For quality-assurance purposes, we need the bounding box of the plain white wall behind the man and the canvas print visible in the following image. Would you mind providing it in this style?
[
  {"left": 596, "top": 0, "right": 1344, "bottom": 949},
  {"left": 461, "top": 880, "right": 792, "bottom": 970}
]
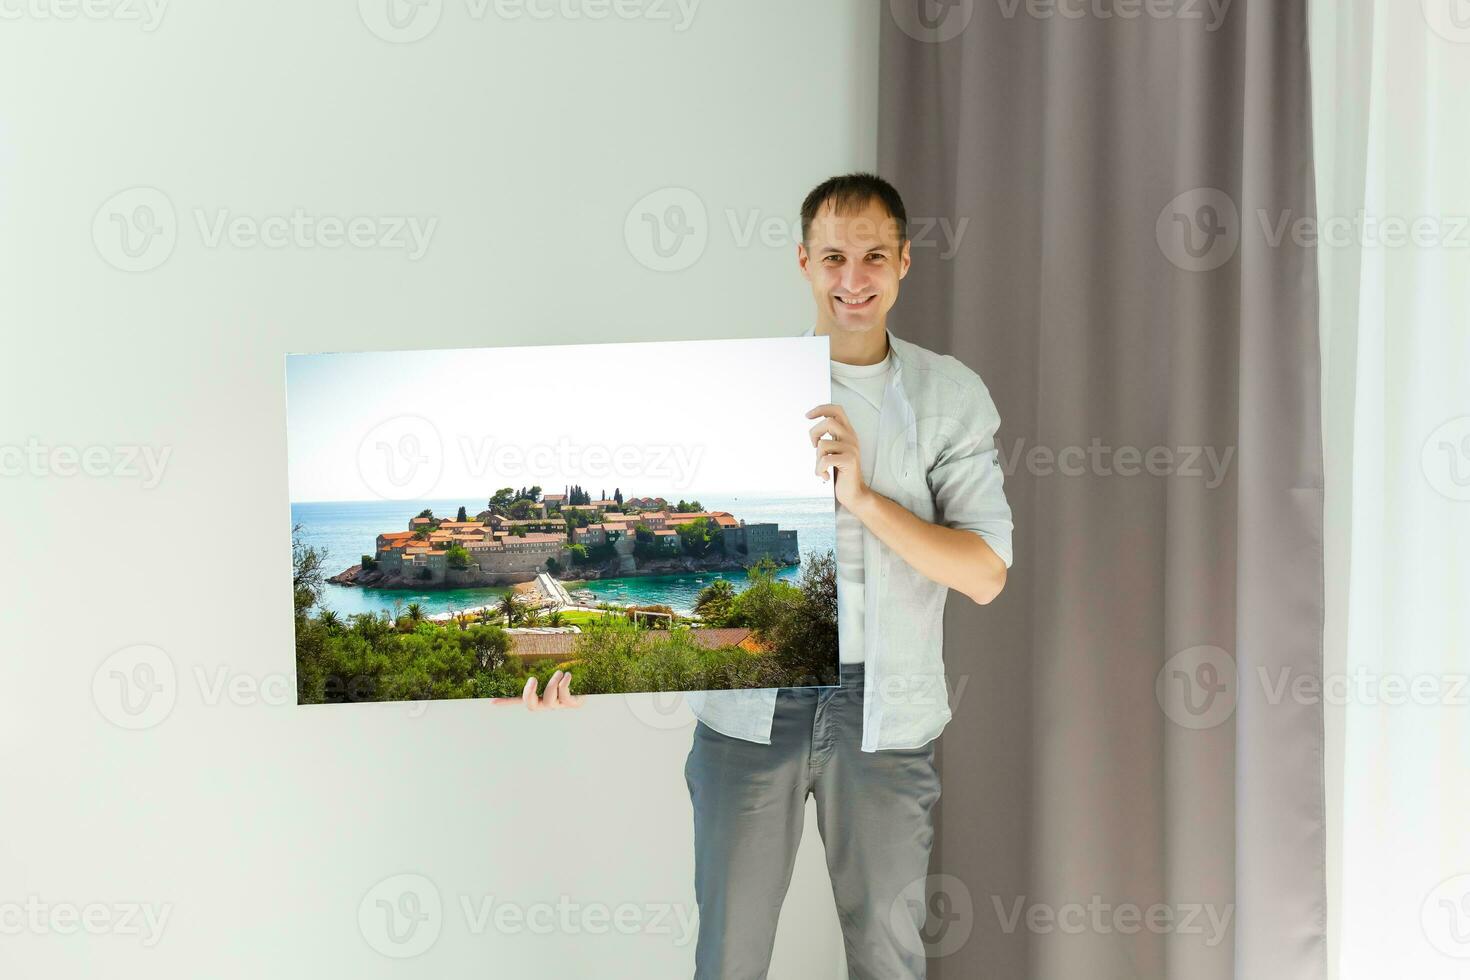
[{"left": 0, "top": 0, "right": 878, "bottom": 979}]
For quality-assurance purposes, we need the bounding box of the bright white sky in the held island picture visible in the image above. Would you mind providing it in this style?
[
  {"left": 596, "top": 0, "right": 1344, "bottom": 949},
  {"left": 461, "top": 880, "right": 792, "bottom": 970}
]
[{"left": 287, "top": 336, "right": 832, "bottom": 501}]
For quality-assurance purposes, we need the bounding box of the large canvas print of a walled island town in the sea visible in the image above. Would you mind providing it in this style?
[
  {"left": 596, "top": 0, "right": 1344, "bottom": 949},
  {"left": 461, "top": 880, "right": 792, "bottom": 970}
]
[{"left": 287, "top": 336, "right": 838, "bottom": 704}]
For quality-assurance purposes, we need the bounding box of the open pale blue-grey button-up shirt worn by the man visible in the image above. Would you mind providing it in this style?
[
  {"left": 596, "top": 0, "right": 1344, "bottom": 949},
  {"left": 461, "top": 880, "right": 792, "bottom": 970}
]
[{"left": 685, "top": 328, "right": 1013, "bottom": 752}]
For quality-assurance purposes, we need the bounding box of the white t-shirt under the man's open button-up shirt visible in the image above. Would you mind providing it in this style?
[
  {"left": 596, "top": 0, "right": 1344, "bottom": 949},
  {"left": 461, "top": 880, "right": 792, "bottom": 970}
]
[{"left": 832, "top": 351, "right": 894, "bottom": 664}]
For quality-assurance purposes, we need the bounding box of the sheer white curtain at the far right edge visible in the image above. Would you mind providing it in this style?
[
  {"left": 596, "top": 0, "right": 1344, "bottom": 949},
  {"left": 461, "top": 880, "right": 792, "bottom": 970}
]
[{"left": 1311, "top": 0, "right": 1470, "bottom": 980}]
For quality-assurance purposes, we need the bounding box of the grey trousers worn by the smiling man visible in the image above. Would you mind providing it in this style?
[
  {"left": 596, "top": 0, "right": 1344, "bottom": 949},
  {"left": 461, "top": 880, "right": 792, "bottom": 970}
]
[{"left": 684, "top": 664, "right": 939, "bottom": 980}]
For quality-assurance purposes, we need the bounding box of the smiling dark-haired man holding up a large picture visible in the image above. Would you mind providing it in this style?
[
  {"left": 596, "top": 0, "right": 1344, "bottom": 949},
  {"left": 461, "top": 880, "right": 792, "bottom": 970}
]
[{"left": 505, "top": 173, "right": 1011, "bottom": 980}]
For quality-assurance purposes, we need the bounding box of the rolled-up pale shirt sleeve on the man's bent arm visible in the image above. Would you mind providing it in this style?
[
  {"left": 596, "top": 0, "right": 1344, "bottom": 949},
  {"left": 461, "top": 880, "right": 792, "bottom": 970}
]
[{"left": 928, "top": 376, "right": 1013, "bottom": 569}]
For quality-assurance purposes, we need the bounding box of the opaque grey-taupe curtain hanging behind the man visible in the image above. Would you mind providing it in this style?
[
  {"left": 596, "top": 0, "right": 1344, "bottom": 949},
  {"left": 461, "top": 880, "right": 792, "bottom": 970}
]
[{"left": 879, "top": 0, "right": 1326, "bottom": 980}]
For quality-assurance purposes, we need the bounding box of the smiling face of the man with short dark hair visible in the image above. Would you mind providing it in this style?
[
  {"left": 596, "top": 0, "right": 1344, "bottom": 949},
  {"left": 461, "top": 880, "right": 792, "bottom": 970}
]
[{"left": 797, "top": 198, "right": 908, "bottom": 334}]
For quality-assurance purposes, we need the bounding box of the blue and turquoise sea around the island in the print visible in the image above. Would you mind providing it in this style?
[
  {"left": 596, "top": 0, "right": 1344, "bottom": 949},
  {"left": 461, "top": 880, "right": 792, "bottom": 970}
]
[{"left": 291, "top": 494, "right": 836, "bottom": 616}]
